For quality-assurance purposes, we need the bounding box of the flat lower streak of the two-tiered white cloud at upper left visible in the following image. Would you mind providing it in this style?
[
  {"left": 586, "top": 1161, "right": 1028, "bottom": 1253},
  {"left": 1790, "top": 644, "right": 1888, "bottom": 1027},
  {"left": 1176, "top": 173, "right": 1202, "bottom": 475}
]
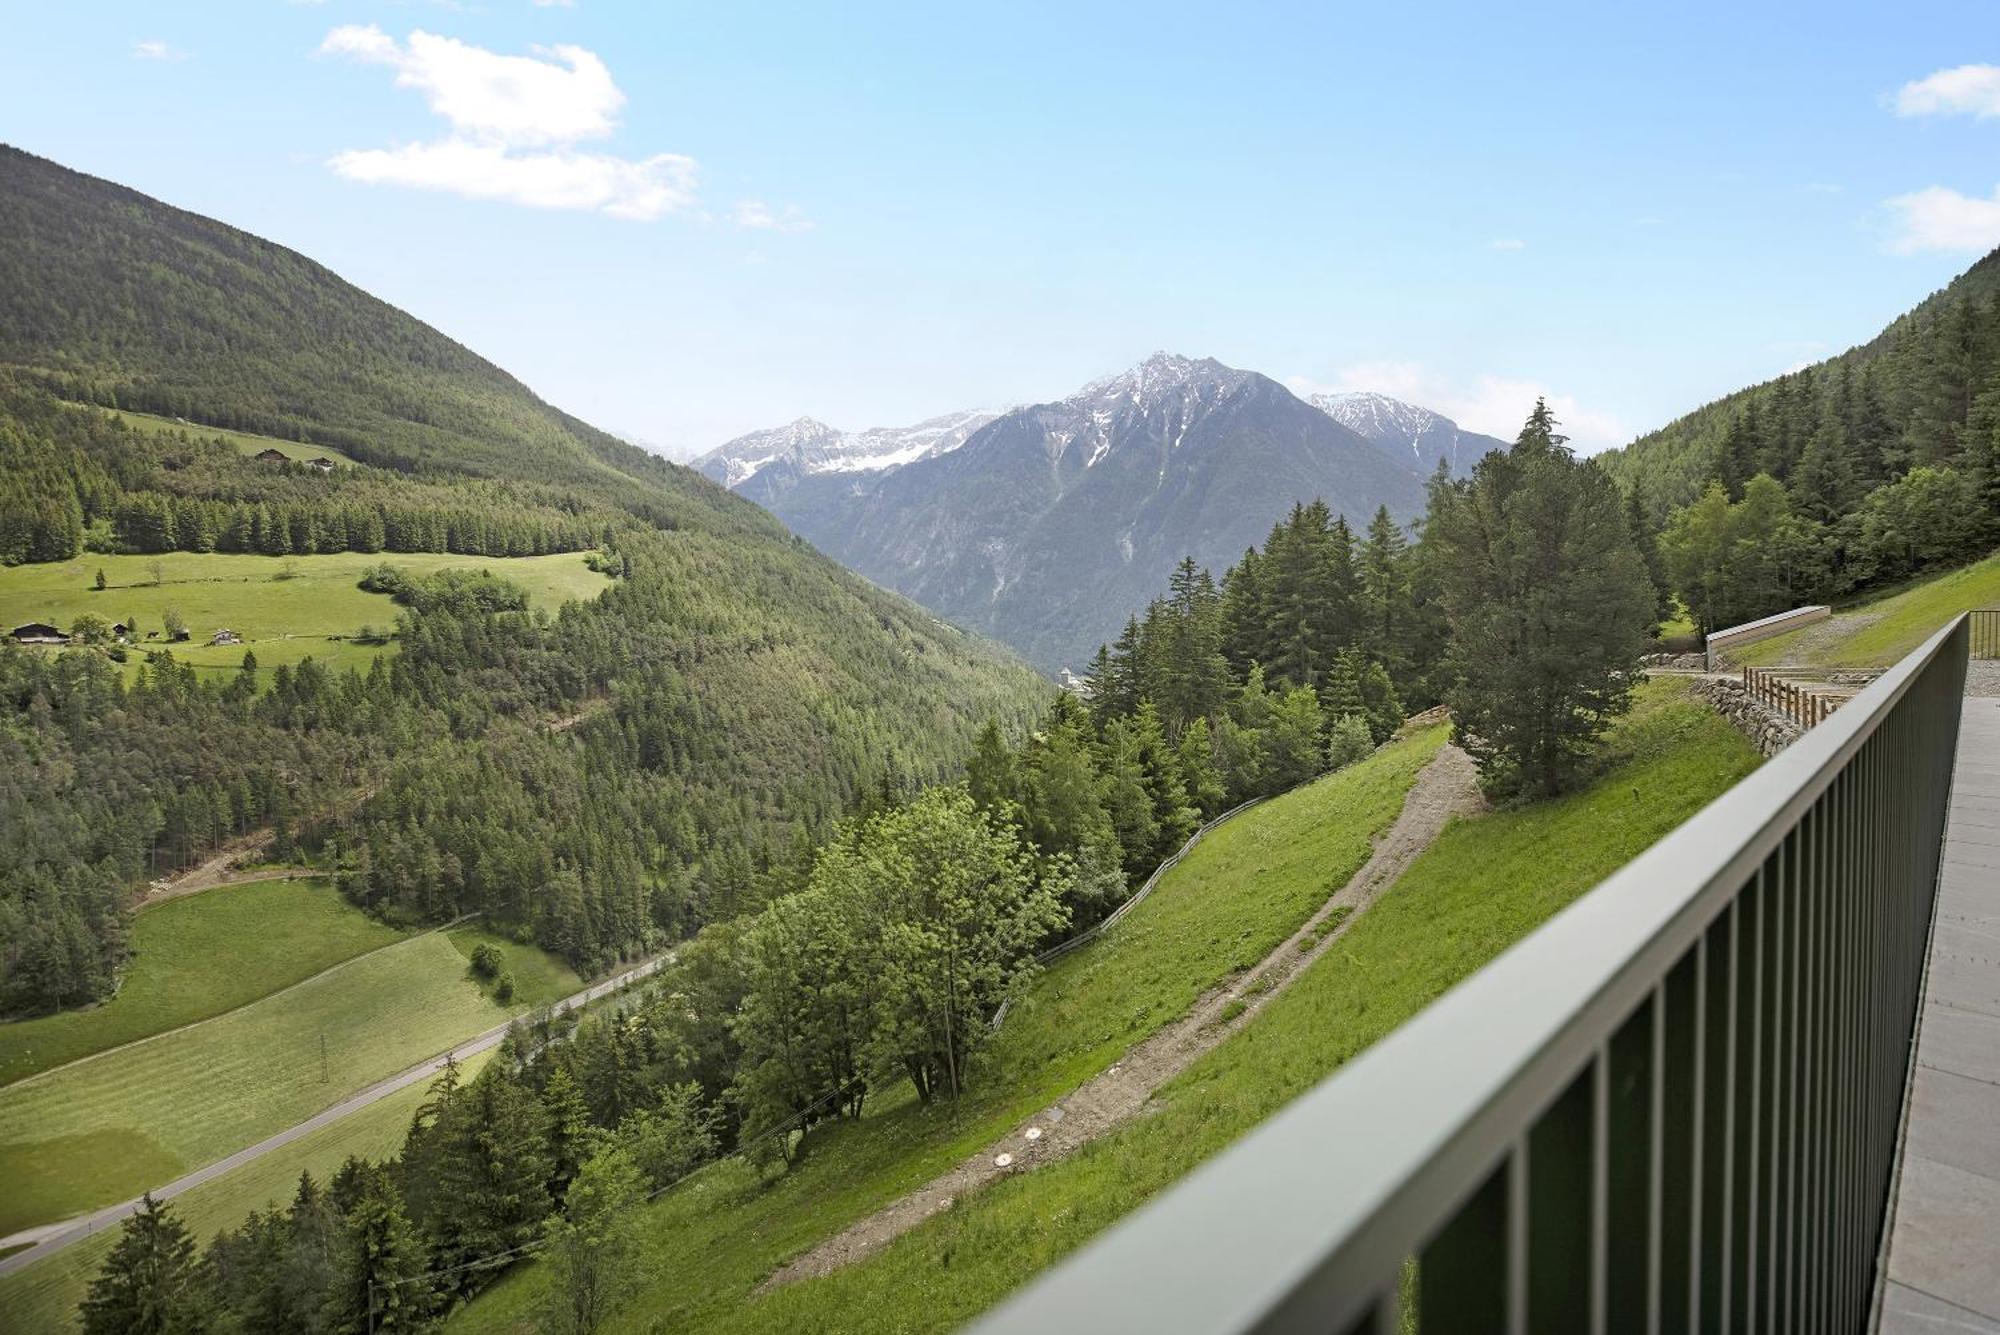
[{"left": 330, "top": 138, "right": 694, "bottom": 222}]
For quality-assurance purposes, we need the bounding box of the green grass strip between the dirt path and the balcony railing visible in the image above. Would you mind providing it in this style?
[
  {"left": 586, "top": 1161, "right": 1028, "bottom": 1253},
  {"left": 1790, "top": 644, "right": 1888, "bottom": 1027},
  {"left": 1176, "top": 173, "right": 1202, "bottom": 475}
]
[{"left": 460, "top": 681, "right": 1758, "bottom": 1335}]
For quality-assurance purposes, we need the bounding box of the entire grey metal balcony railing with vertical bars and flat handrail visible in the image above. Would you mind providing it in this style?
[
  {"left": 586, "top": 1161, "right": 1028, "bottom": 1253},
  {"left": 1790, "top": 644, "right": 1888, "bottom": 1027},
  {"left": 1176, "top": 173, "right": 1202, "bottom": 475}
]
[{"left": 982, "top": 616, "right": 1970, "bottom": 1335}]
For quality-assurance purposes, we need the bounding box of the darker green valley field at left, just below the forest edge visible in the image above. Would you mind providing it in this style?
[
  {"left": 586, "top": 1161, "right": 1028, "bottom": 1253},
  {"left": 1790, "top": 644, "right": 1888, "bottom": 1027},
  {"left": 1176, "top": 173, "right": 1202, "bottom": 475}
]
[{"left": 0, "top": 877, "right": 404, "bottom": 1085}]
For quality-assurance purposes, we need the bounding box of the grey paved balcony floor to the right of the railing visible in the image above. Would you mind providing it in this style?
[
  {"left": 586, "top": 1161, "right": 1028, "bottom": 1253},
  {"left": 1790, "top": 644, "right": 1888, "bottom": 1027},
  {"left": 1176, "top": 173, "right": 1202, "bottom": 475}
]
[{"left": 1878, "top": 695, "right": 2000, "bottom": 1335}]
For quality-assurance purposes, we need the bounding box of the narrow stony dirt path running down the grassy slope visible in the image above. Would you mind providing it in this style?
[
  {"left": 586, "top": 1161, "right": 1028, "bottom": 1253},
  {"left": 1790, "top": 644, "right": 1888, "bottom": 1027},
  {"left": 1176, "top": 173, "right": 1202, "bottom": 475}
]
[{"left": 760, "top": 745, "right": 1480, "bottom": 1291}]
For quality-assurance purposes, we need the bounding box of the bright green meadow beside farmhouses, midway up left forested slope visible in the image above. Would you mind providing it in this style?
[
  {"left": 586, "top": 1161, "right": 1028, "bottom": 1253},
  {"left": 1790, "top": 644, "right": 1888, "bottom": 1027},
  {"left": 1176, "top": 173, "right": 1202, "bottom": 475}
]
[{"left": 0, "top": 552, "right": 610, "bottom": 673}]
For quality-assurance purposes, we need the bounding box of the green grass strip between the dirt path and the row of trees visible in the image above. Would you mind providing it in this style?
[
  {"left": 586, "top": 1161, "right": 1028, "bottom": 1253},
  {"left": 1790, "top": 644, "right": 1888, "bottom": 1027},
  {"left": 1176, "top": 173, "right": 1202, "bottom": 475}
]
[{"left": 450, "top": 727, "right": 1446, "bottom": 1329}]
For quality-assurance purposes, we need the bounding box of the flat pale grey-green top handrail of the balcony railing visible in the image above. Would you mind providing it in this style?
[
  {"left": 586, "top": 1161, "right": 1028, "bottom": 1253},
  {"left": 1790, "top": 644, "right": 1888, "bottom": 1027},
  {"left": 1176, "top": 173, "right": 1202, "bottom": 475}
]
[{"left": 982, "top": 616, "right": 1966, "bottom": 1333}]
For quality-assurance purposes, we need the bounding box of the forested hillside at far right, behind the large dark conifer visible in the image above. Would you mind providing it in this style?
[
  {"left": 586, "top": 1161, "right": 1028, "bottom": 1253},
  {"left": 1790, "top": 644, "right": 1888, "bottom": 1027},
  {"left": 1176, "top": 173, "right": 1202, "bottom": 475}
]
[{"left": 1604, "top": 252, "right": 2000, "bottom": 632}]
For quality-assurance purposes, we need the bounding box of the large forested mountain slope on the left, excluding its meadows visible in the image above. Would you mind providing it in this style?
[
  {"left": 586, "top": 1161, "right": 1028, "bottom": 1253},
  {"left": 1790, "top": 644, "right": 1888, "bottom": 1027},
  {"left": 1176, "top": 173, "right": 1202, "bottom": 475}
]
[{"left": 0, "top": 148, "right": 1044, "bottom": 1011}]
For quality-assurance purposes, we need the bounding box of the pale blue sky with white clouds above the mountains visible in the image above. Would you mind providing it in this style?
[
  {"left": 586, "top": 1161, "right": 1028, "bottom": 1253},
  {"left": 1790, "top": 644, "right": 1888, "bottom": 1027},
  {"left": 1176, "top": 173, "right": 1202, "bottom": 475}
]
[{"left": 0, "top": 0, "right": 2000, "bottom": 458}]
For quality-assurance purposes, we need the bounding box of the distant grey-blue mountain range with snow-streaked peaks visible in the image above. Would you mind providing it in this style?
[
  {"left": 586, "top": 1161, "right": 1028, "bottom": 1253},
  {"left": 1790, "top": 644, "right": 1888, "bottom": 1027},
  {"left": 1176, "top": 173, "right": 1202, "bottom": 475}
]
[{"left": 696, "top": 352, "right": 1504, "bottom": 671}]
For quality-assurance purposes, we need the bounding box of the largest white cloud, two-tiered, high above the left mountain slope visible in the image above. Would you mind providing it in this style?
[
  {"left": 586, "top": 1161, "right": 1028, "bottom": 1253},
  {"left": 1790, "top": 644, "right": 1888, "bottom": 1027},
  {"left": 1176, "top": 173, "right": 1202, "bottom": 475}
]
[{"left": 320, "top": 24, "right": 696, "bottom": 220}]
